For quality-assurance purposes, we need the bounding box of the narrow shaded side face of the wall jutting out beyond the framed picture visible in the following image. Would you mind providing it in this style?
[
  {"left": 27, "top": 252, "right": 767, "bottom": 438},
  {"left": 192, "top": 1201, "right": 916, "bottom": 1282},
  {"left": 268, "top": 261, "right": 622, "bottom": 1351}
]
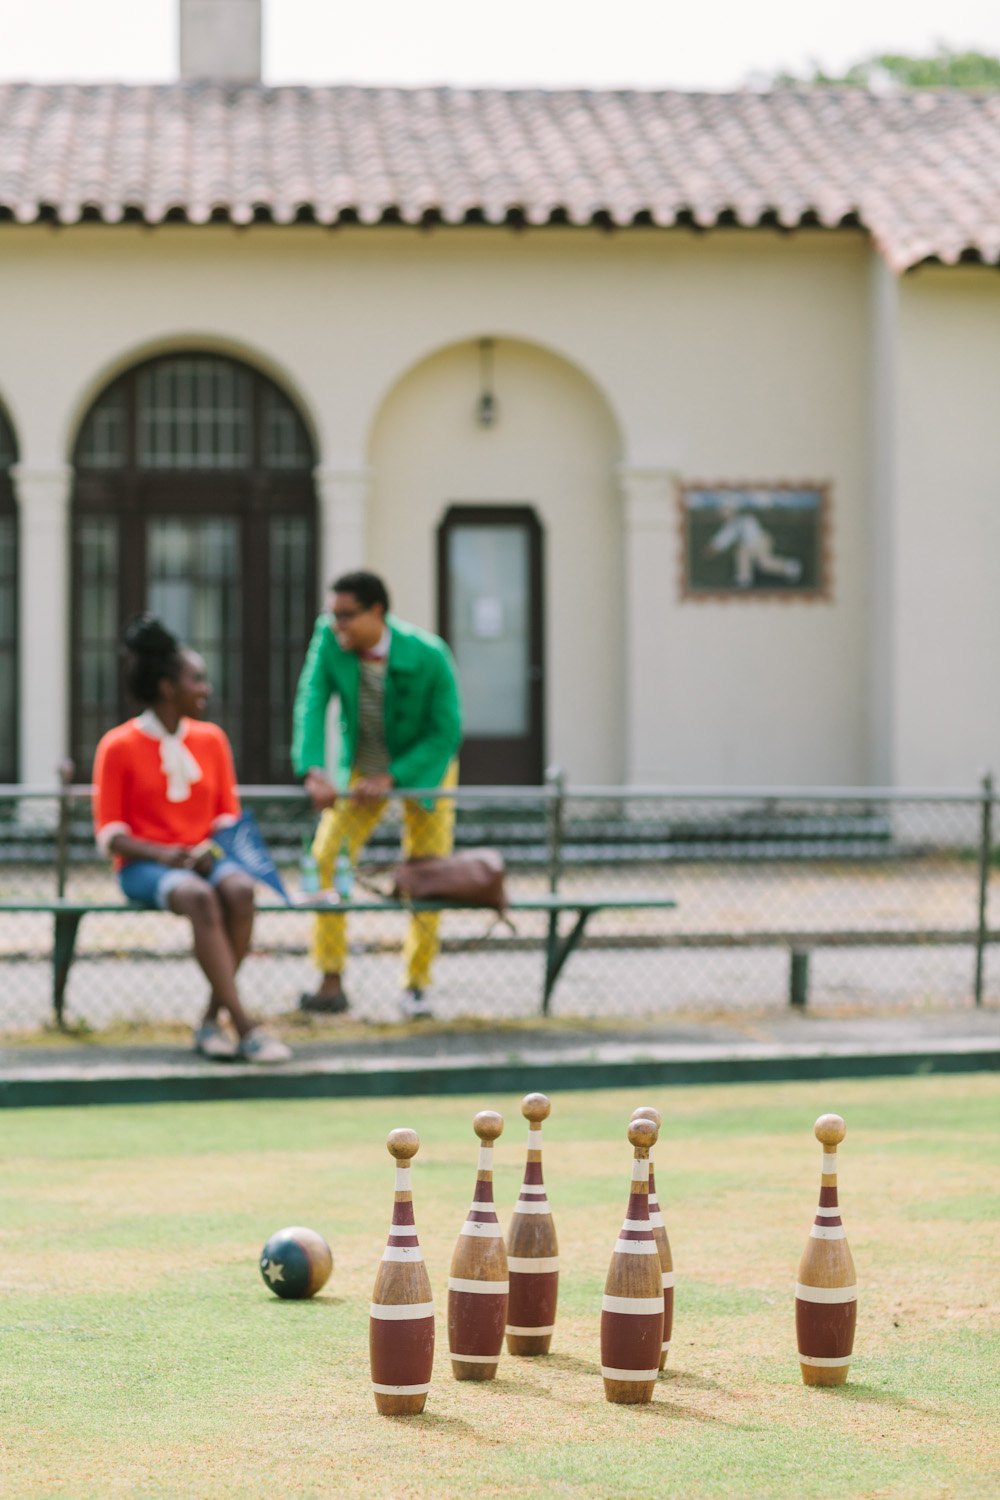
[{"left": 868, "top": 252, "right": 900, "bottom": 786}]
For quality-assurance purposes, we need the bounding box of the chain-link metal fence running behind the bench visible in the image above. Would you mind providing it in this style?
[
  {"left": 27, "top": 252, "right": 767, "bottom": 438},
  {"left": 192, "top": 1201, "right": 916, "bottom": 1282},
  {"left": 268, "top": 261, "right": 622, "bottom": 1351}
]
[{"left": 0, "top": 776, "right": 1000, "bottom": 1031}]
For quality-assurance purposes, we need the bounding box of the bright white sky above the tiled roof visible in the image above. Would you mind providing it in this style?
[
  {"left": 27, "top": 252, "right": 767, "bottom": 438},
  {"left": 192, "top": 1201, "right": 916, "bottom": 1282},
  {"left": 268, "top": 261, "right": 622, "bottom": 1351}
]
[{"left": 0, "top": 0, "right": 1000, "bottom": 89}]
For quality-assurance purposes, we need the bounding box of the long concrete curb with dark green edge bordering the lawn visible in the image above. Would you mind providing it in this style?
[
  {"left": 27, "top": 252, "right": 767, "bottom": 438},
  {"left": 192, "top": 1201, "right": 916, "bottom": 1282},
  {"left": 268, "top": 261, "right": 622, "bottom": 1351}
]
[{"left": 0, "top": 1038, "right": 1000, "bottom": 1109}]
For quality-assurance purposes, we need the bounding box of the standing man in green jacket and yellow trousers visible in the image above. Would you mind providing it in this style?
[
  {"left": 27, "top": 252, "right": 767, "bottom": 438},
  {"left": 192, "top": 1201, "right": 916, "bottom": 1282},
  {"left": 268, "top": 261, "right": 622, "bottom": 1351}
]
[{"left": 292, "top": 572, "right": 462, "bottom": 1019}]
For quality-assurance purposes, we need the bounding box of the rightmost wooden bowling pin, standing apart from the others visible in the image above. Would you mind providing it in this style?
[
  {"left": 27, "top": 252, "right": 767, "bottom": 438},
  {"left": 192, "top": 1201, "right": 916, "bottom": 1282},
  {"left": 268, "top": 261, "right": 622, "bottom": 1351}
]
[{"left": 795, "top": 1115, "right": 858, "bottom": 1386}]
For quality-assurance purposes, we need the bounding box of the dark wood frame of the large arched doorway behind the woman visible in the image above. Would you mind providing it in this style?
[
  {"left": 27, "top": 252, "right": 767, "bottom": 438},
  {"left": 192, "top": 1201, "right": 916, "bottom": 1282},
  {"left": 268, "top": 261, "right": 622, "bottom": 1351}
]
[{"left": 70, "top": 348, "right": 319, "bottom": 783}]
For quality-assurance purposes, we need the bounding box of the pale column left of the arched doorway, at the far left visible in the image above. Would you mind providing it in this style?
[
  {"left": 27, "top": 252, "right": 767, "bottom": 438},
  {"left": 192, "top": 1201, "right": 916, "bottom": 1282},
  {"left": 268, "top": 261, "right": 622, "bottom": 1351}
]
[{"left": 12, "top": 464, "right": 73, "bottom": 785}]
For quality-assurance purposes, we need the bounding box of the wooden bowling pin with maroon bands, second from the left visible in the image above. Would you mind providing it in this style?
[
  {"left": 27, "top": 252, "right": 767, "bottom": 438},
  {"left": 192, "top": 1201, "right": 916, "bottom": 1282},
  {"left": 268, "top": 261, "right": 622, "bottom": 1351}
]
[{"left": 448, "top": 1110, "right": 508, "bottom": 1380}]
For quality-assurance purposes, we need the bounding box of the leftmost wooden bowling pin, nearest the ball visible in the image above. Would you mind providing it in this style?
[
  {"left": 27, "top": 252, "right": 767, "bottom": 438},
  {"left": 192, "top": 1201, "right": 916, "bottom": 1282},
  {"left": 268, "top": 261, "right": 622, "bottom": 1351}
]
[{"left": 369, "top": 1130, "right": 433, "bottom": 1416}]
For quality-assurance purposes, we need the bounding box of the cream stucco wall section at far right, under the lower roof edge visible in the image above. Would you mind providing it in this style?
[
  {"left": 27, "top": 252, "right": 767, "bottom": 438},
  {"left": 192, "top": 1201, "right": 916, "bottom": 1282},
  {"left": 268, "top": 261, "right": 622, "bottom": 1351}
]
[{"left": 894, "top": 266, "right": 1000, "bottom": 786}]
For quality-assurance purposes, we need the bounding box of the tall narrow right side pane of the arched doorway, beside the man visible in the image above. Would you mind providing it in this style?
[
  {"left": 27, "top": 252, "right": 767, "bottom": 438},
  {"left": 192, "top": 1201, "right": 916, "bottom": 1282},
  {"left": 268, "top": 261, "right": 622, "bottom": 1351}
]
[{"left": 270, "top": 516, "right": 313, "bottom": 777}]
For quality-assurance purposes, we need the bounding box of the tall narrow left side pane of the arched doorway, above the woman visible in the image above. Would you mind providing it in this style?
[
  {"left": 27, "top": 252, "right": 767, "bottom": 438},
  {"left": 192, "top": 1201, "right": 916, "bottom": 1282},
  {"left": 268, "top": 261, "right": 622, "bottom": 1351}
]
[{"left": 75, "top": 518, "right": 118, "bottom": 765}]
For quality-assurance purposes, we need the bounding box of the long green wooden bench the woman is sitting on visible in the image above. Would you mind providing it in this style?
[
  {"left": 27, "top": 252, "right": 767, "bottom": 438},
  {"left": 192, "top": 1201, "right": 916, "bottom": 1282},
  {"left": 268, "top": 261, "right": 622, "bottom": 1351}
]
[{"left": 0, "top": 894, "right": 676, "bottom": 1026}]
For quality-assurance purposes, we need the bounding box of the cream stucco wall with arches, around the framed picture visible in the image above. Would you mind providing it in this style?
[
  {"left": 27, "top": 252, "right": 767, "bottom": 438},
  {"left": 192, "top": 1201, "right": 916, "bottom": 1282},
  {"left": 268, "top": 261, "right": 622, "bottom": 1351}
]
[{"left": 0, "top": 225, "right": 870, "bottom": 785}]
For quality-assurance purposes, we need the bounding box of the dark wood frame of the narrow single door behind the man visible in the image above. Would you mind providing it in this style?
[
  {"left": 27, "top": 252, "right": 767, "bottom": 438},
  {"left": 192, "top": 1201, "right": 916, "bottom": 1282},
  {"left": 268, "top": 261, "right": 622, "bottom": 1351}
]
[{"left": 438, "top": 503, "right": 546, "bottom": 785}]
